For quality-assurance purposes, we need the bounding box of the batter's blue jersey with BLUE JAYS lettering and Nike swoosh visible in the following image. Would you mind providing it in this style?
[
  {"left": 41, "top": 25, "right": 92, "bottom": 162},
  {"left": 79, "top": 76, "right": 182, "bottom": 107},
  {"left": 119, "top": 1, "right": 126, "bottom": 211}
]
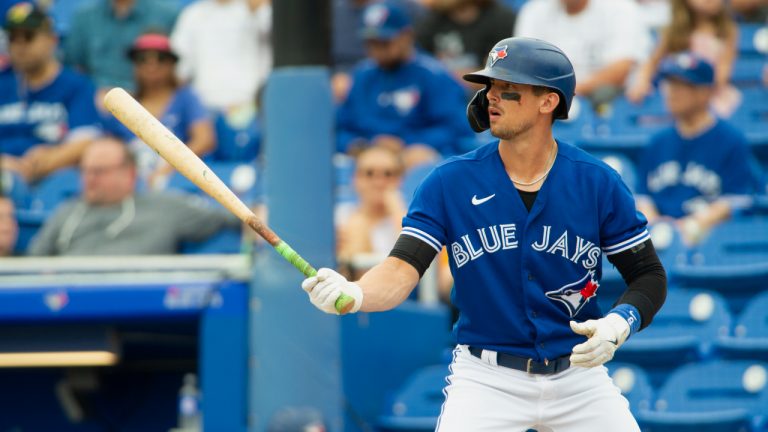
[{"left": 402, "top": 141, "right": 649, "bottom": 361}]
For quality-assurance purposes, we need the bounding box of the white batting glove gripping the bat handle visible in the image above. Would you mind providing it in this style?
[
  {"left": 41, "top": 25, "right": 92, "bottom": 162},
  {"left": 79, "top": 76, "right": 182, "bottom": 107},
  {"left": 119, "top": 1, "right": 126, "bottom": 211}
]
[{"left": 301, "top": 268, "right": 363, "bottom": 315}]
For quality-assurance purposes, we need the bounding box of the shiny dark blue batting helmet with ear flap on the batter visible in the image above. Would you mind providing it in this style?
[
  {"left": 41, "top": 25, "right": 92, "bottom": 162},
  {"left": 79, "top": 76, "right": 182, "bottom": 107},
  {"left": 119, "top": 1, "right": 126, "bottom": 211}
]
[{"left": 464, "top": 37, "right": 576, "bottom": 119}]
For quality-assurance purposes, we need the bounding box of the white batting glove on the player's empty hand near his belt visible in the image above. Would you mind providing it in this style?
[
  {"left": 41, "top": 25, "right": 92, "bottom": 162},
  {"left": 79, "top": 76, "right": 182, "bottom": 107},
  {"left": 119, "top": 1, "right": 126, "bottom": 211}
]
[{"left": 571, "top": 313, "right": 629, "bottom": 367}]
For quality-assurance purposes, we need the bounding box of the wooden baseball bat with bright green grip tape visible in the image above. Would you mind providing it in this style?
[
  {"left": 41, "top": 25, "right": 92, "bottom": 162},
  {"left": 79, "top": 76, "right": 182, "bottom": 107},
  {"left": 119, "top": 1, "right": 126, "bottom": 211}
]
[{"left": 104, "top": 87, "right": 355, "bottom": 314}]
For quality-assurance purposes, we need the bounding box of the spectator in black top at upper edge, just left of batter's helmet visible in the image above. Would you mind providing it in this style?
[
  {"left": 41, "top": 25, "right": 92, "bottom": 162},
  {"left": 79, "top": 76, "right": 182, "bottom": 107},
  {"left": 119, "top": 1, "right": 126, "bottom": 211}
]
[{"left": 416, "top": 0, "right": 515, "bottom": 82}]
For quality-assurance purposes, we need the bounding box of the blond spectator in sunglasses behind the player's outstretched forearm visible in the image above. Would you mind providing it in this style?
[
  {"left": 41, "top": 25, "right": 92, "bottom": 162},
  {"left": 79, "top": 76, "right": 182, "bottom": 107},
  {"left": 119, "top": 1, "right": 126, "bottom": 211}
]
[{"left": 337, "top": 147, "right": 406, "bottom": 277}]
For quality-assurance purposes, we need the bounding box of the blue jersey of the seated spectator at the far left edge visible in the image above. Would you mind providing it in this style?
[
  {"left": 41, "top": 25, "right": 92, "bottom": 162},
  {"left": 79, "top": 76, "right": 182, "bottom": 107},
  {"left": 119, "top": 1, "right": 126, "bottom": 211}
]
[{"left": 0, "top": 67, "right": 100, "bottom": 156}]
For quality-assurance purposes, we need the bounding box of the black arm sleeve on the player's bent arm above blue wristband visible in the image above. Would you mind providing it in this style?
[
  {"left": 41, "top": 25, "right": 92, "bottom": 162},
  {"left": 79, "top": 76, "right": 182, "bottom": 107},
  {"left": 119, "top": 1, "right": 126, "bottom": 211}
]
[{"left": 608, "top": 239, "right": 667, "bottom": 330}]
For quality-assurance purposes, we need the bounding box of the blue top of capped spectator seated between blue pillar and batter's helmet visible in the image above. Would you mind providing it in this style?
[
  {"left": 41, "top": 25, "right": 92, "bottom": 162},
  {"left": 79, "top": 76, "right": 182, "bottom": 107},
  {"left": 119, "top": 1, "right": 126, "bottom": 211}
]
[{"left": 336, "top": 54, "right": 475, "bottom": 155}]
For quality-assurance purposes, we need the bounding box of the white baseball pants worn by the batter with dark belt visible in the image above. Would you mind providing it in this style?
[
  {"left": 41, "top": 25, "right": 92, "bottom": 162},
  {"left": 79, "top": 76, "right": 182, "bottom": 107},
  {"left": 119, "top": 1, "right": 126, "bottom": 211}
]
[{"left": 437, "top": 345, "right": 640, "bottom": 432}]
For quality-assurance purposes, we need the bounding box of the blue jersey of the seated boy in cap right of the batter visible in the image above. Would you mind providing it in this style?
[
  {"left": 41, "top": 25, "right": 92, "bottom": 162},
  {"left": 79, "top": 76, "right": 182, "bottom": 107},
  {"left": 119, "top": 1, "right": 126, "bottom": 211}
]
[{"left": 636, "top": 120, "right": 759, "bottom": 218}]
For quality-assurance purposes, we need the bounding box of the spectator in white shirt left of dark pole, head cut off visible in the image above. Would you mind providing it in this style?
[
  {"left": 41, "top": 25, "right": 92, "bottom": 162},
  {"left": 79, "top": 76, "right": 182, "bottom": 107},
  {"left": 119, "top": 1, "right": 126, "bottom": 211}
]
[{"left": 171, "top": 0, "right": 272, "bottom": 111}]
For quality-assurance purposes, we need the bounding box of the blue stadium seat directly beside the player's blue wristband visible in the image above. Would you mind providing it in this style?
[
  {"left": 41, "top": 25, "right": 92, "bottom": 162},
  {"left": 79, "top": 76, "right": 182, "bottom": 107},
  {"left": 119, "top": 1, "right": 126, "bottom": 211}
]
[{"left": 615, "top": 288, "right": 731, "bottom": 387}]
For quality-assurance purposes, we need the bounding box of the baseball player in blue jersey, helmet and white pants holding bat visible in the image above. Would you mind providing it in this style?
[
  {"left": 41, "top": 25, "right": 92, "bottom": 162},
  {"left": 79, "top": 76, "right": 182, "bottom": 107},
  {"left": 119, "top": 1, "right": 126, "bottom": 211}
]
[{"left": 302, "top": 37, "right": 666, "bottom": 432}]
